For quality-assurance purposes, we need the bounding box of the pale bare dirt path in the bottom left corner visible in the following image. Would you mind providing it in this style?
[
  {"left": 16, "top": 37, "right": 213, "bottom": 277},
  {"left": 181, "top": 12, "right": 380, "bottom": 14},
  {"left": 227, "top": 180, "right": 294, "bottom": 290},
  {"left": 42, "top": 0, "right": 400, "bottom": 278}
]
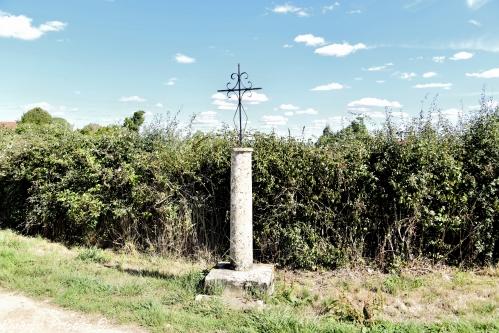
[{"left": 0, "top": 290, "right": 145, "bottom": 333}]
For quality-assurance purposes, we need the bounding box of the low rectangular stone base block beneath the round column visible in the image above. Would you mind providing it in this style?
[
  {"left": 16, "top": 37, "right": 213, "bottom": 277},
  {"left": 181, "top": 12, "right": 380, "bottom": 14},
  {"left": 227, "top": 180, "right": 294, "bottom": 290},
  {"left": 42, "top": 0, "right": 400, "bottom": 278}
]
[{"left": 204, "top": 263, "right": 274, "bottom": 295}]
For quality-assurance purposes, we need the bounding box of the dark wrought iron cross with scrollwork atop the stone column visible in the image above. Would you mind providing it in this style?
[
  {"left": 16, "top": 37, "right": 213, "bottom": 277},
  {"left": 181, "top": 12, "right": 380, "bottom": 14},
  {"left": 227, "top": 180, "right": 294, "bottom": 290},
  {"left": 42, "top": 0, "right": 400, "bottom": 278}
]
[{"left": 217, "top": 64, "right": 262, "bottom": 146}]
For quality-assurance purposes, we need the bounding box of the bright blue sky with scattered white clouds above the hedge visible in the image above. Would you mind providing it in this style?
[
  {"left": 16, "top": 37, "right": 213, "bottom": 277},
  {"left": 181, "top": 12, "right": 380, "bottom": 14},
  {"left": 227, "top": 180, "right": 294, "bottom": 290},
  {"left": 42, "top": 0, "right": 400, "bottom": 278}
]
[{"left": 0, "top": 0, "right": 499, "bottom": 135}]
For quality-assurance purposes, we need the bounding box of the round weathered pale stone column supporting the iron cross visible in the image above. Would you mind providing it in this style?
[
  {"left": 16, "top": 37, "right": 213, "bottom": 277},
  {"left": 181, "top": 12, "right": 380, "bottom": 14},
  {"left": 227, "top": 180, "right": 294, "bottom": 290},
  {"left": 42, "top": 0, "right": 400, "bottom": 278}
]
[{"left": 230, "top": 148, "right": 253, "bottom": 271}]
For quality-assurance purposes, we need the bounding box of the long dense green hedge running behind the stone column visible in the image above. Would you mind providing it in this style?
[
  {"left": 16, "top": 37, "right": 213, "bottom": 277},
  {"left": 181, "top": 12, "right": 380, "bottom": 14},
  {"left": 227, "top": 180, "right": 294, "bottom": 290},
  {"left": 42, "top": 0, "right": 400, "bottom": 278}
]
[{"left": 0, "top": 105, "right": 499, "bottom": 268}]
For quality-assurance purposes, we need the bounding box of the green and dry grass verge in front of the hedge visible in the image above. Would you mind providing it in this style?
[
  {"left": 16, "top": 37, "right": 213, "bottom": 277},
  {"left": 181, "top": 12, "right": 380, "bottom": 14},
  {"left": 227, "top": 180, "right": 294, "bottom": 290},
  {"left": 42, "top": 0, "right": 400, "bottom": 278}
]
[{"left": 0, "top": 231, "right": 499, "bottom": 332}]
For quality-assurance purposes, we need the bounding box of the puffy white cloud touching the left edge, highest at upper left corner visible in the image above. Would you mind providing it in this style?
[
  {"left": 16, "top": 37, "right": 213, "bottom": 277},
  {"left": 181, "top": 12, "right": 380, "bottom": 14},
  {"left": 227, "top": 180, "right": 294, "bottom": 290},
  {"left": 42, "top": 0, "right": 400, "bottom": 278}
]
[{"left": 0, "top": 11, "right": 67, "bottom": 40}]
